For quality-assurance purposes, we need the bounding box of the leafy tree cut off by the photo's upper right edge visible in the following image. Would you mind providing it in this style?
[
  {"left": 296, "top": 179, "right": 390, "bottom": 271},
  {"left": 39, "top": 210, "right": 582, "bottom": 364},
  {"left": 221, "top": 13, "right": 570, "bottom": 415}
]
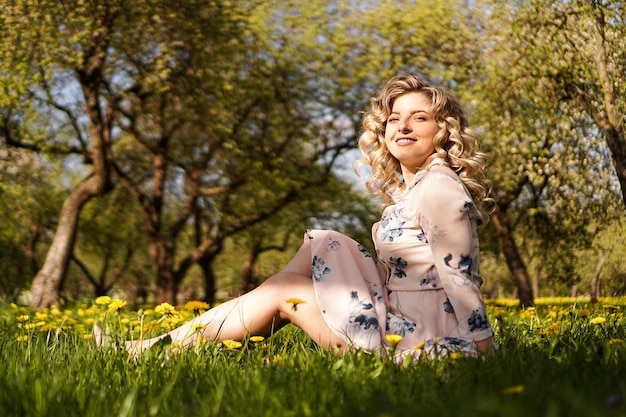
[{"left": 525, "top": 0, "right": 626, "bottom": 205}]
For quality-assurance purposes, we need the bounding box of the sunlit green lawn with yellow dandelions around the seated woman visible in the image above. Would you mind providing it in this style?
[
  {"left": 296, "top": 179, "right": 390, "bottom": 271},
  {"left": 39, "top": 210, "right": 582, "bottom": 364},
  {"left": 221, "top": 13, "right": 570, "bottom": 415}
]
[{"left": 0, "top": 303, "right": 626, "bottom": 417}]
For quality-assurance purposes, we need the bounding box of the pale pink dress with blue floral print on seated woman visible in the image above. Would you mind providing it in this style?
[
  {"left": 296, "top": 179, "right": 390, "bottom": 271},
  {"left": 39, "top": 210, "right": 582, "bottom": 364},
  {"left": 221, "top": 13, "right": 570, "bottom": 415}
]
[{"left": 305, "top": 160, "right": 493, "bottom": 360}]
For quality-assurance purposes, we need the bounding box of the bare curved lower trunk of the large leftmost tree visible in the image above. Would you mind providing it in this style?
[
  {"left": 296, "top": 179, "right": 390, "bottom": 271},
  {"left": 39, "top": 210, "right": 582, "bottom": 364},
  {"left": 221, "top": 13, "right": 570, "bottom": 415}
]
[{"left": 30, "top": 175, "right": 105, "bottom": 308}]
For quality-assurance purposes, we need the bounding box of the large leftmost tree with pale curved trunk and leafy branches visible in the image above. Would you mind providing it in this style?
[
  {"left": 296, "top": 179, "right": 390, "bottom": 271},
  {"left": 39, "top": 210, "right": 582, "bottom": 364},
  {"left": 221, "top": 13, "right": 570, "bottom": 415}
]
[{"left": 0, "top": 1, "right": 135, "bottom": 307}]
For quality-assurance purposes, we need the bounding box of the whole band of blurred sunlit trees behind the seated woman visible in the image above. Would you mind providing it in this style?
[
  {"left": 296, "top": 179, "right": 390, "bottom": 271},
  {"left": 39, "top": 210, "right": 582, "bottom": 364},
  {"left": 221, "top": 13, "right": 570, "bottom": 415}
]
[{"left": 0, "top": 0, "right": 626, "bottom": 307}]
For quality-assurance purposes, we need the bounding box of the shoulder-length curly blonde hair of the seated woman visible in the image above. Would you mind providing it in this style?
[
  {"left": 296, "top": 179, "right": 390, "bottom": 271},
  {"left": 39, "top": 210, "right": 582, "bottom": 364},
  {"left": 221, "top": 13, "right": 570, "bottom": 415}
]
[{"left": 355, "top": 74, "right": 493, "bottom": 219}]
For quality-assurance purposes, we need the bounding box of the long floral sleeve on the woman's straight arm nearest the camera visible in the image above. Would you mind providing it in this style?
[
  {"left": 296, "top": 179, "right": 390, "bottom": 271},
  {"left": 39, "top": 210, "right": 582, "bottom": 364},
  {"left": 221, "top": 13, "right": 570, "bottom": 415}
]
[{"left": 419, "top": 175, "right": 493, "bottom": 341}]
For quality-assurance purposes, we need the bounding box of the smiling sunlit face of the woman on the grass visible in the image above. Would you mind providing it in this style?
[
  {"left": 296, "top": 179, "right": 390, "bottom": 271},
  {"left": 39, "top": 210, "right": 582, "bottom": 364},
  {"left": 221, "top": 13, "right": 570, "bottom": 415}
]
[{"left": 385, "top": 93, "right": 439, "bottom": 176}]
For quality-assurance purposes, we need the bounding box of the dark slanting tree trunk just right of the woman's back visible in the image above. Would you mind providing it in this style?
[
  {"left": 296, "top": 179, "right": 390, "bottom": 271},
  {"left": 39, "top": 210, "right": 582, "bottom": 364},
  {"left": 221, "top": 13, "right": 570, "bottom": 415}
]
[{"left": 493, "top": 209, "right": 534, "bottom": 307}]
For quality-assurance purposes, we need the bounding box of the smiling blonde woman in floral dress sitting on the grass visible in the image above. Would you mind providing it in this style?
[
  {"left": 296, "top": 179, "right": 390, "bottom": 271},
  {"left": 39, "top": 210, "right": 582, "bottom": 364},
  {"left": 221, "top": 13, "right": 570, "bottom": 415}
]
[{"left": 95, "top": 75, "right": 493, "bottom": 360}]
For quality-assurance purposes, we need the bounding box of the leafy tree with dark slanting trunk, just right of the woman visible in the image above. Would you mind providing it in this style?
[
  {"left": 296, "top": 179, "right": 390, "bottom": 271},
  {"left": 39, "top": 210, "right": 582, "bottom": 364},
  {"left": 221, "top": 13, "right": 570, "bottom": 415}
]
[{"left": 473, "top": 2, "right": 611, "bottom": 305}]
